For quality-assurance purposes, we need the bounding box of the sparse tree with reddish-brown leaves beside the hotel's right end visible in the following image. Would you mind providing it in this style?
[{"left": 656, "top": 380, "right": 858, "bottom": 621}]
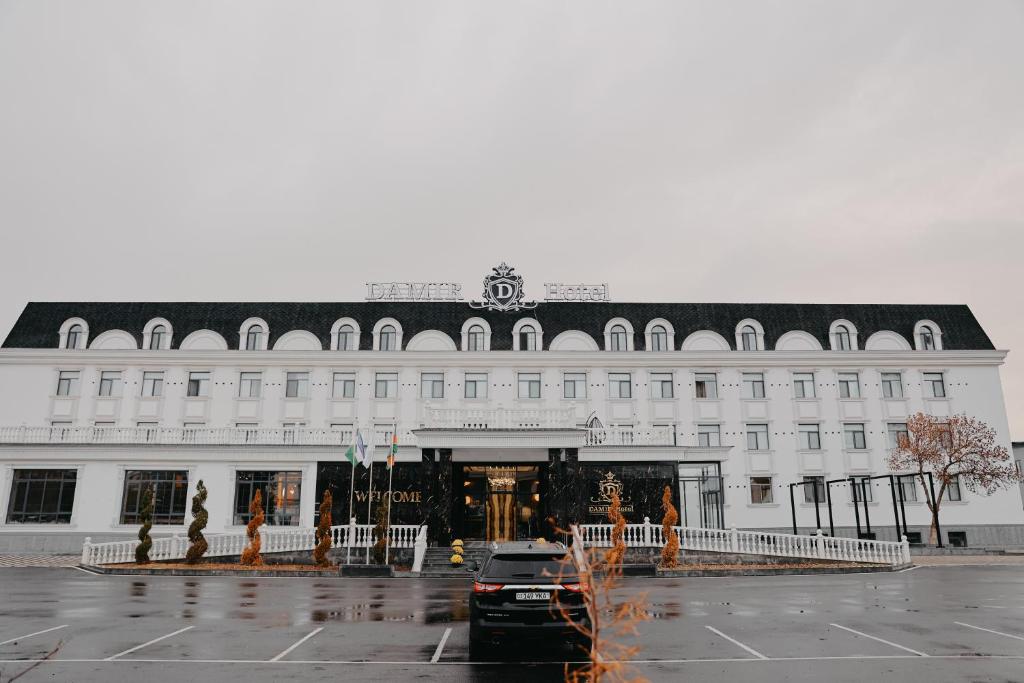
[{"left": 889, "top": 413, "right": 1021, "bottom": 545}]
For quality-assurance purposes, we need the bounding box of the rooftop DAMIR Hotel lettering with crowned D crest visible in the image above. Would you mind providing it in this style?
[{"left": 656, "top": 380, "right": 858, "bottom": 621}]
[{"left": 366, "top": 262, "right": 610, "bottom": 312}]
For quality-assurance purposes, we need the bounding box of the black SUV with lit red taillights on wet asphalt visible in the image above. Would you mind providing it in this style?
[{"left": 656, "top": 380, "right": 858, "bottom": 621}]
[{"left": 468, "top": 541, "right": 590, "bottom": 653}]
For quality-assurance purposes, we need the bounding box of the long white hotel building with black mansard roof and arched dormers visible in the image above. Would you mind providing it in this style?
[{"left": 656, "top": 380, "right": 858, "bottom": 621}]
[{"left": 0, "top": 301, "right": 1024, "bottom": 552}]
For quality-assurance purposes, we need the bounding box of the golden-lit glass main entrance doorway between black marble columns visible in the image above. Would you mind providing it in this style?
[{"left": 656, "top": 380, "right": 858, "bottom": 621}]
[{"left": 462, "top": 465, "right": 541, "bottom": 543}]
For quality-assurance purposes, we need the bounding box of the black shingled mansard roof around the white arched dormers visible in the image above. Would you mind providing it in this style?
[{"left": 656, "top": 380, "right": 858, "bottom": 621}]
[{"left": 3, "top": 301, "right": 994, "bottom": 350}]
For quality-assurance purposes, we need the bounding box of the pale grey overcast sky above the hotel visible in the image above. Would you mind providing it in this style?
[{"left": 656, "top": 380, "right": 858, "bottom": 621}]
[{"left": 0, "top": 0, "right": 1024, "bottom": 432}]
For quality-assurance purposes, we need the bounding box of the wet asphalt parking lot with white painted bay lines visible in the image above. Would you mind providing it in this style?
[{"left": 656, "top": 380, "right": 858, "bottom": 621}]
[{"left": 0, "top": 566, "right": 1024, "bottom": 683}]
